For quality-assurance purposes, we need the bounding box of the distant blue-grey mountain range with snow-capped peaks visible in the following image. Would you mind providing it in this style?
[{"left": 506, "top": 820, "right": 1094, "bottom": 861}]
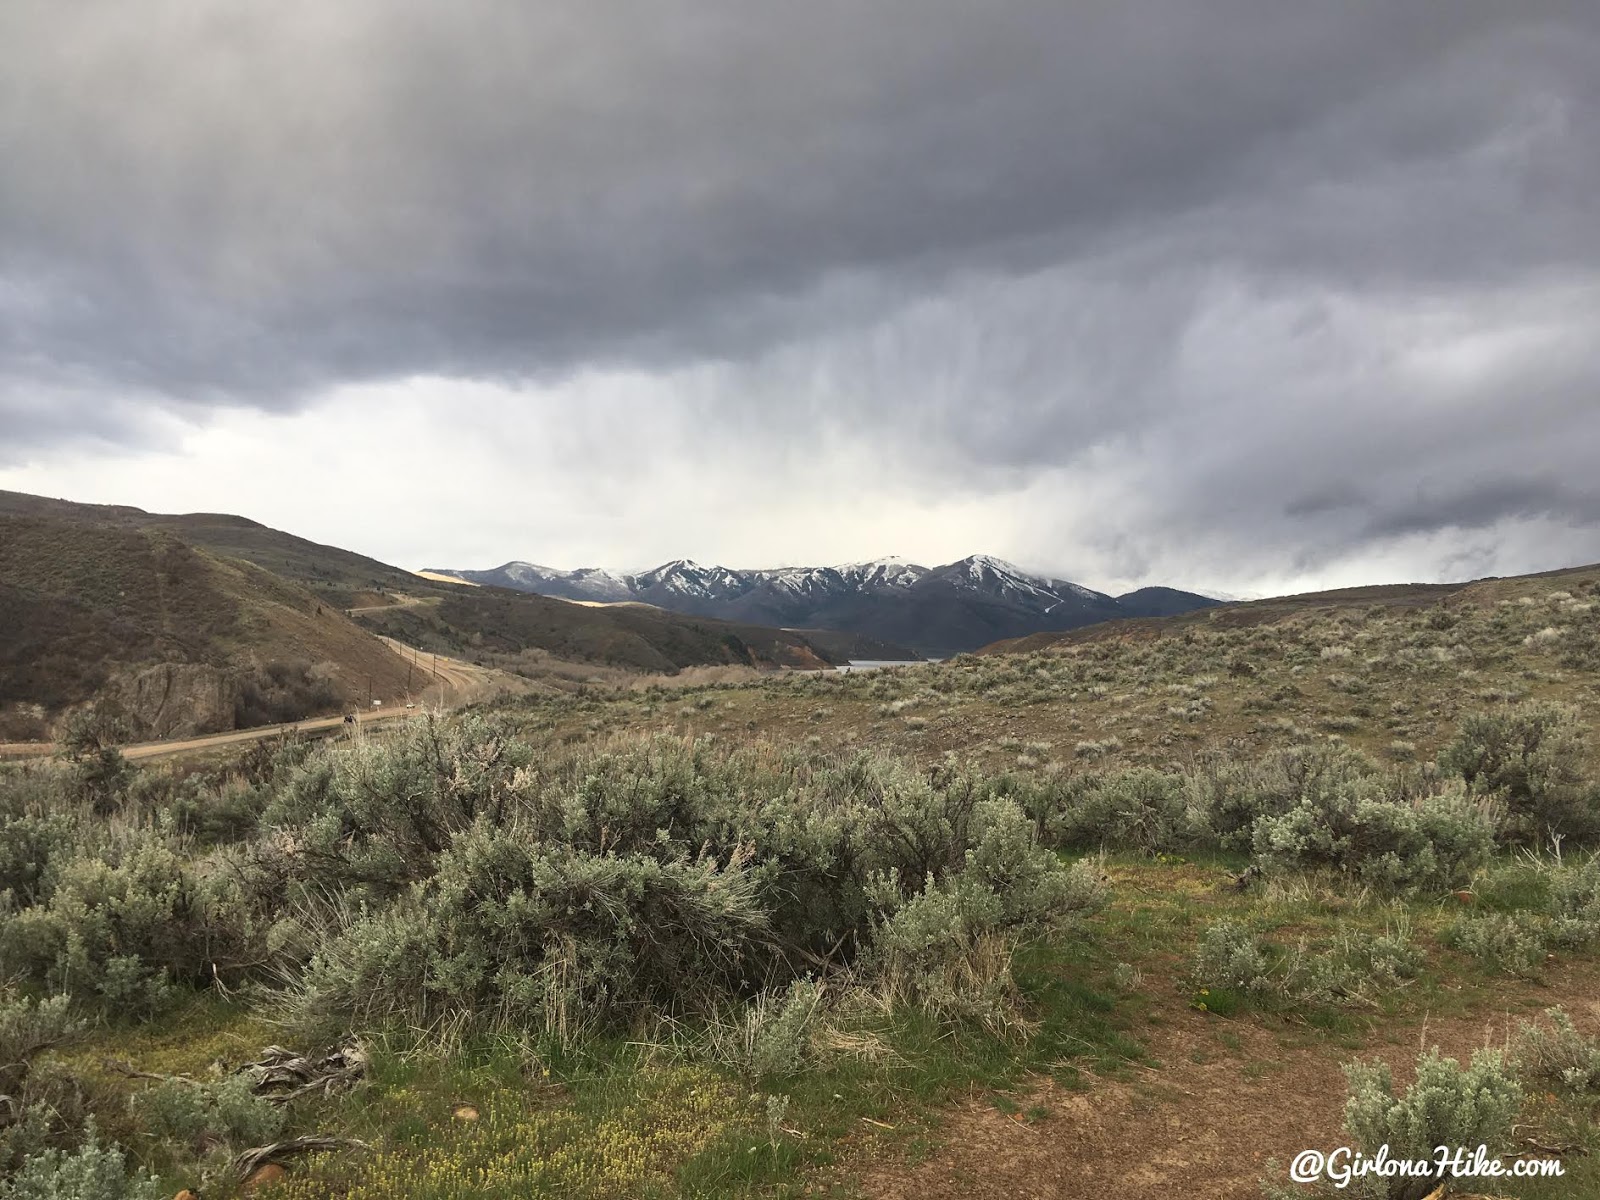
[{"left": 429, "top": 554, "right": 1219, "bottom": 654}]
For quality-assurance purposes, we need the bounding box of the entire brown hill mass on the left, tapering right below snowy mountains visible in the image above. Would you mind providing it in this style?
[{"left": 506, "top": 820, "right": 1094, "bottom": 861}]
[{"left": 0, "top": 491, "right": 910, "bottom": 741}]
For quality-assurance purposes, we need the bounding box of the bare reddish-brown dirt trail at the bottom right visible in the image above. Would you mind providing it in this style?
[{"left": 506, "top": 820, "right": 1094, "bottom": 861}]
[{"left": 835, "top": 963, "right": 1600, "bottom": 1200}]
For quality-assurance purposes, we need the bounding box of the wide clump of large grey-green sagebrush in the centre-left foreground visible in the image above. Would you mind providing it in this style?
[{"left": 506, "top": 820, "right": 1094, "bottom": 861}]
[{"left": 250, "top": 720, "right": 1098, "bottom": 1032}]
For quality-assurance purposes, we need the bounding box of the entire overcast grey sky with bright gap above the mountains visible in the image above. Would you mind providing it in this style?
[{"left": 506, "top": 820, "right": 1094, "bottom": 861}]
[{"left": 0, "top": 0, "right": 1600, "bottom": 594}]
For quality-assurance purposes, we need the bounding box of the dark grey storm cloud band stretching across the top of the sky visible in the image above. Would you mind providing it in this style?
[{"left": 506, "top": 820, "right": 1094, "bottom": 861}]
[{"left": 0, "top": 0, "right": 1594, "bottom": 403}]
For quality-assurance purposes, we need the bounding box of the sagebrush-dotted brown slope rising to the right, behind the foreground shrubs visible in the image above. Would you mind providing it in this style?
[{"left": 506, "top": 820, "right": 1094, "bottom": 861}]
[{"left": 499, "top": 566, "right": 1600, "bottom": 771}]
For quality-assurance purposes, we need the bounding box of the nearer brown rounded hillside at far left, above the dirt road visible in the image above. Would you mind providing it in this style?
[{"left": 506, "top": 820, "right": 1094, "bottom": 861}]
[{"left": 0, "top": 515, "right": 405, "bottom": 741}]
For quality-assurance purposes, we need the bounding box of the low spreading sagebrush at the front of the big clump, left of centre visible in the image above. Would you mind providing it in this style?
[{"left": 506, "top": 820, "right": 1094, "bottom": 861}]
[{"left": 304, "top": 822, "right": 774, "bottom": 1034}]
